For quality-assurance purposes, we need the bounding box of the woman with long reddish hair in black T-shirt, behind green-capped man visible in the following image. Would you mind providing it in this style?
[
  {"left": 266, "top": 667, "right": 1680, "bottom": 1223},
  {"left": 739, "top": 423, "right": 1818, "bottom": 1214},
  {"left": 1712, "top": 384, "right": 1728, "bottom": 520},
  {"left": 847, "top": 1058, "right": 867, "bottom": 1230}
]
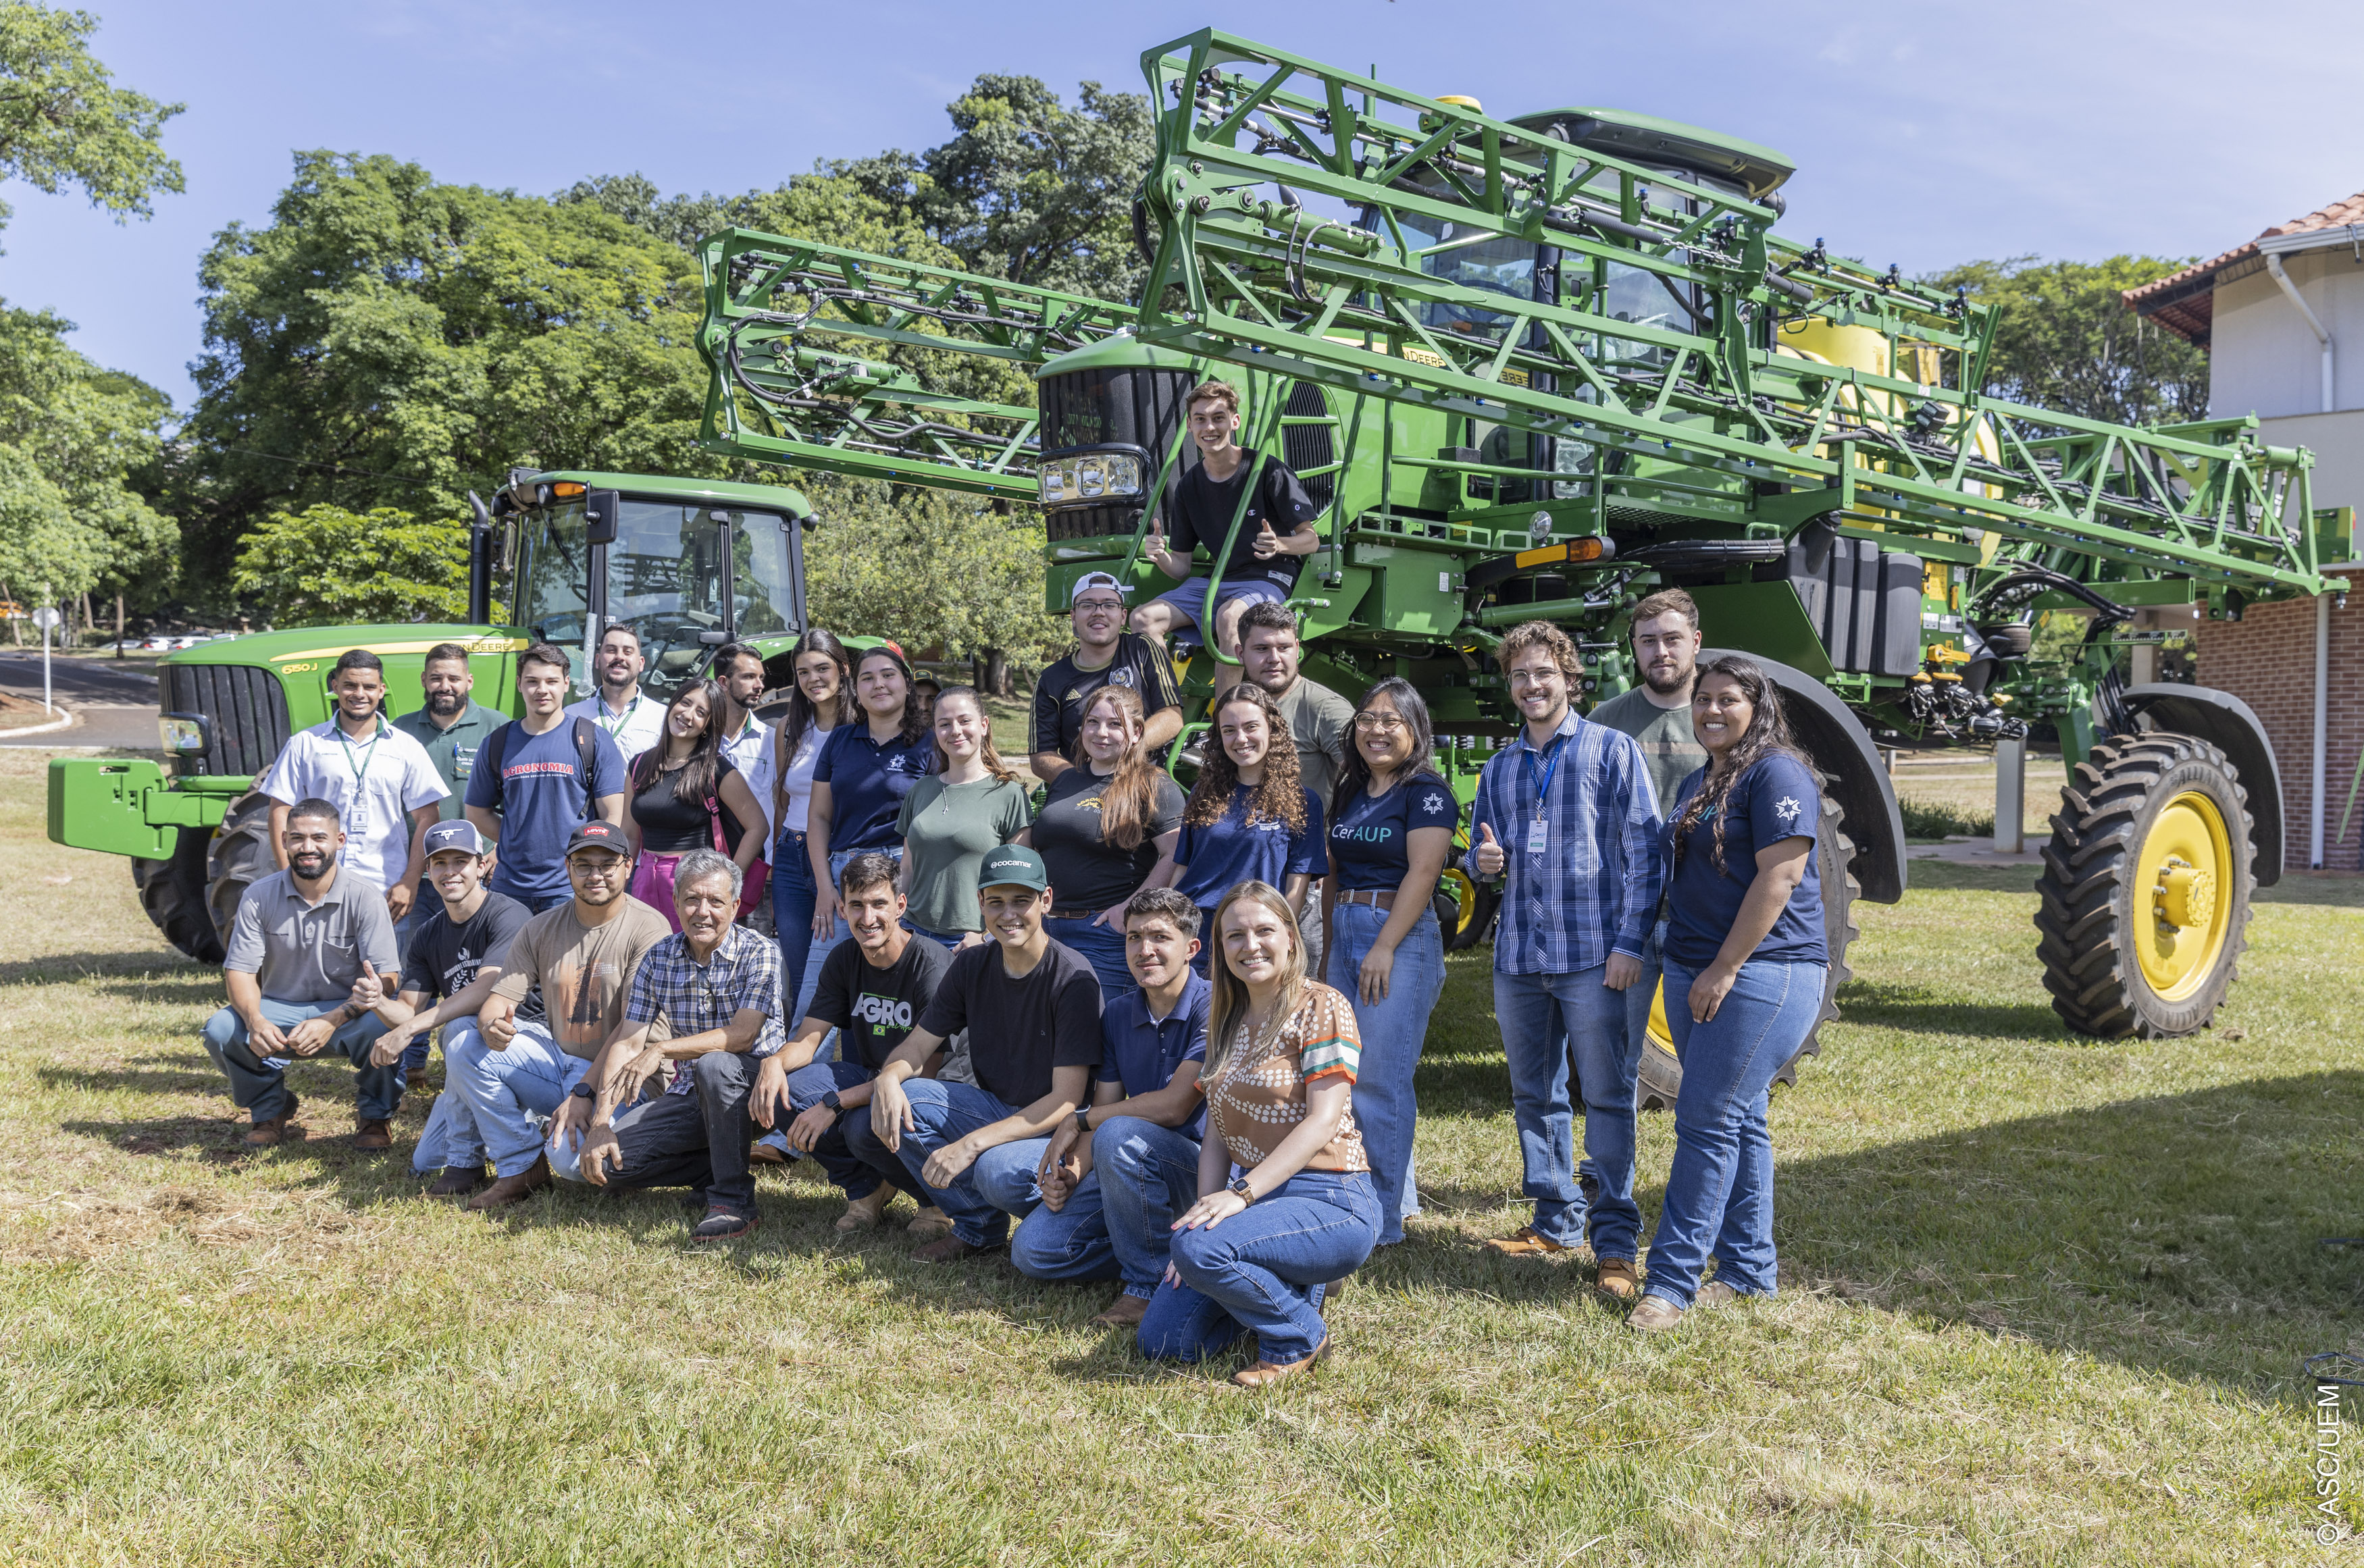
[{"left": 1019, "top": 686, "right": 1182, "bottom": 1008}]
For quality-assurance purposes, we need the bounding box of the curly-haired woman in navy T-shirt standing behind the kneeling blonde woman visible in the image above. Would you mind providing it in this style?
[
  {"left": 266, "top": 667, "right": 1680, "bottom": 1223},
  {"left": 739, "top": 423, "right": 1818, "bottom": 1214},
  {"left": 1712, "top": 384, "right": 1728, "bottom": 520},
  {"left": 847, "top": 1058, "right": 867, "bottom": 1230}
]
[{"left": 1166, "top": 681, "right": 1329, "bottom": 974}]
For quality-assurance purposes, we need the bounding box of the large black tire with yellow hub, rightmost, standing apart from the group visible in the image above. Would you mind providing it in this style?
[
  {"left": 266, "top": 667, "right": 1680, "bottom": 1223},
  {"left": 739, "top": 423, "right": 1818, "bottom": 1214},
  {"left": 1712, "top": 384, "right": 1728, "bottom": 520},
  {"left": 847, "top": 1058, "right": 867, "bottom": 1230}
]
[{"left": 2036, "top": 733, "right": 2253, "bottom": 1041}]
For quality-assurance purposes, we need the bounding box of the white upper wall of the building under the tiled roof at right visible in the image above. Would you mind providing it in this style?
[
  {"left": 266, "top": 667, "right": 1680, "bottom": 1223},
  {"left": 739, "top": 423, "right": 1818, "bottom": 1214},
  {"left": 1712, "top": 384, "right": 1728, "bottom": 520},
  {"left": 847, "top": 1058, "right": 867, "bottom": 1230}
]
[{"left": 2208, "top": 246, "right": 2364, "bottom": 421}]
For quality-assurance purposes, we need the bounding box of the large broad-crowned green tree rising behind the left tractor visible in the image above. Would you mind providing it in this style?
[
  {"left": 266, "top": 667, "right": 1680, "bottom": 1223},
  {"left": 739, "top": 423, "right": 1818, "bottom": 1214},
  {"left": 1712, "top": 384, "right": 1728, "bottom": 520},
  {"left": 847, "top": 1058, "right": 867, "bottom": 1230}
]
[{"left": 175, "top": 151, "right": 723, "bottom": 598}]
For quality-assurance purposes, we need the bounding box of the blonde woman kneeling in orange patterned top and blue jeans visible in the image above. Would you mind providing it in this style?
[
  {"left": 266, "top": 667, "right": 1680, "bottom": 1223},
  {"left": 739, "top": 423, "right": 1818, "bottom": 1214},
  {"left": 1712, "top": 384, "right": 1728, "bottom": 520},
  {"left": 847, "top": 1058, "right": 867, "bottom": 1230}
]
[{"left": 1139, "top": 882, "right": 1379, "bottom": 1388}]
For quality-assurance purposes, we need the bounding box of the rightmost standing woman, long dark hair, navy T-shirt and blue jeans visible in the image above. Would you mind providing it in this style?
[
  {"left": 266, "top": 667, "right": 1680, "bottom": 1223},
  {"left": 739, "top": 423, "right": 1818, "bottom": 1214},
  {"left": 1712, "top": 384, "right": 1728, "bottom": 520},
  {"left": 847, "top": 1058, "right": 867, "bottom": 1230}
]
[{"left": 1626, "top": 655, "right": 1830, "bottom": 1334}]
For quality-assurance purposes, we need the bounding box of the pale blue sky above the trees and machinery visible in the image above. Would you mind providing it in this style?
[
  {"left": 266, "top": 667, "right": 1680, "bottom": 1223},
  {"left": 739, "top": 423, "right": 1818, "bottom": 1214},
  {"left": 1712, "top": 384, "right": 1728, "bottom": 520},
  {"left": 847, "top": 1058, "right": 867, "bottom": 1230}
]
[{"left": 14, "top": 0, "right": 2364, "bottom": 407}]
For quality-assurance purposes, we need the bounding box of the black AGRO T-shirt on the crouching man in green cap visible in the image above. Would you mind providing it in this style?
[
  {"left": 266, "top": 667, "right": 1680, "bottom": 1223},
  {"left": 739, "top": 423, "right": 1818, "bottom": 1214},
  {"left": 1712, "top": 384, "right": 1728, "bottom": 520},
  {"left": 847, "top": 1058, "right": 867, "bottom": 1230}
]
[{"left": 920, "top": 941, "right": 1100, "bottom": 1107}]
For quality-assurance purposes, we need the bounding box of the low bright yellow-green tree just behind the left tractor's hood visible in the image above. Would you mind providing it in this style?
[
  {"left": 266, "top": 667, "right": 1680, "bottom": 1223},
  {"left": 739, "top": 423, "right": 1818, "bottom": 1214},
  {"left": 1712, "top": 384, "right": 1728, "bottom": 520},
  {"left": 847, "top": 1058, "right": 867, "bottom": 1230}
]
[{"left": 232, "top": 504, "right": 501, "bottom": 627}]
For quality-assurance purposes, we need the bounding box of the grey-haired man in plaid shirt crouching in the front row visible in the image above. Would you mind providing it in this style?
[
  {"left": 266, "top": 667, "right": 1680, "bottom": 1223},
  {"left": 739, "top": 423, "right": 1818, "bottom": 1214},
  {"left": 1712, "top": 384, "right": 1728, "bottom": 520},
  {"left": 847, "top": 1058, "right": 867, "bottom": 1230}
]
[{"left": 551, "top": 849, "right": 788, "bottom": 1242}]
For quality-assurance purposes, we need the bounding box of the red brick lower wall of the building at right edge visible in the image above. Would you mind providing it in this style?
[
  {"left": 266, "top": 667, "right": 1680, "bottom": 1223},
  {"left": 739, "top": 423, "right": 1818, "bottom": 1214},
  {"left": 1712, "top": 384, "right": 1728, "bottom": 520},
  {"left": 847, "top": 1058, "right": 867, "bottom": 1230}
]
[{"left": 2194, "top": 570, "right": 2364, "bottom": 870}]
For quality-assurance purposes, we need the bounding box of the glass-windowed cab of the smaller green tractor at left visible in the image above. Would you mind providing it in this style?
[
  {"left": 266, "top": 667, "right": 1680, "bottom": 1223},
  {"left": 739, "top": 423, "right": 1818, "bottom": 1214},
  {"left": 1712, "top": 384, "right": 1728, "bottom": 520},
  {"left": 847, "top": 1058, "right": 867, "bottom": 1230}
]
[{"left": 487, "top": 471, "right": 816, "bottom": 698}]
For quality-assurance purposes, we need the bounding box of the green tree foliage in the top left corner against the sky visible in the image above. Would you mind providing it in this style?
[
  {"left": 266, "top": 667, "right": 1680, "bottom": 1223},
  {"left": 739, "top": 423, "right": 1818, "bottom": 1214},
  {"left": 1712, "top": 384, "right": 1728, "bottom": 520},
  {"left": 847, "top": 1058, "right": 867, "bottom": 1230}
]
[{"left": 0, "top": 0, "right": 182, "bottom": 225}]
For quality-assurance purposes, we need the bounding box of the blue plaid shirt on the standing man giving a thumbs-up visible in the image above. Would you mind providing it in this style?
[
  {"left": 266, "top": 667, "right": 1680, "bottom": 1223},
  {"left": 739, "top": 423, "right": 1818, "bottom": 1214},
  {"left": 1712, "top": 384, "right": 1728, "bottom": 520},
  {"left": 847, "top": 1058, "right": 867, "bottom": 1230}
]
[{"left": 1470, "top": 710, "right": 1667, "bottom": 974}]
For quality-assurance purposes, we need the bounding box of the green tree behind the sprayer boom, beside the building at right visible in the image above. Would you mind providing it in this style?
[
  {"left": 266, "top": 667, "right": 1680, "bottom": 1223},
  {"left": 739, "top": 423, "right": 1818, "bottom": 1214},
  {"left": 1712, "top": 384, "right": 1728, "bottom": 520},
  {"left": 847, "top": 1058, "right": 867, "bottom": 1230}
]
[{"left": 1927, "top": 255, "right": 2208, "bottom": 425}]
